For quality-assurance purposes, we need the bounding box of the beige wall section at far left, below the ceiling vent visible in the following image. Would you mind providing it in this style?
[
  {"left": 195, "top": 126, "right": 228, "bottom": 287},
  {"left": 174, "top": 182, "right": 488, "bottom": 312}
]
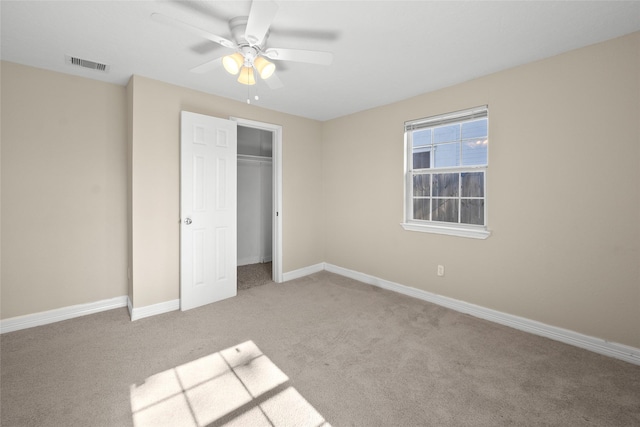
[{"left": 0, "top": 62, "right": 127, "bottom": 319}]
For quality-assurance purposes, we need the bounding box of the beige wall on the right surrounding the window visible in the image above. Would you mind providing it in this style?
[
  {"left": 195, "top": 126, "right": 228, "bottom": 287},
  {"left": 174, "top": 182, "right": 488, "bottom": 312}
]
[{"left": 323, "top": 33, "right": 640, "bottom": 347}]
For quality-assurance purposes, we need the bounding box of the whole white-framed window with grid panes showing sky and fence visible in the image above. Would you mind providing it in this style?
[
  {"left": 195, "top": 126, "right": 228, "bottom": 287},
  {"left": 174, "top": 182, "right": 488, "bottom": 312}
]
[{"left": 402, "top": 106, "right": 489, "bottom": 239}]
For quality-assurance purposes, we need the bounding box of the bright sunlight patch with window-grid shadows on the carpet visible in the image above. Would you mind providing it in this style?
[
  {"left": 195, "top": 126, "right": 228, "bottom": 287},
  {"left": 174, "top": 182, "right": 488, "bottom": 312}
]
[{"left": 130, "top": 341, "right": 330, "bottom": 427}]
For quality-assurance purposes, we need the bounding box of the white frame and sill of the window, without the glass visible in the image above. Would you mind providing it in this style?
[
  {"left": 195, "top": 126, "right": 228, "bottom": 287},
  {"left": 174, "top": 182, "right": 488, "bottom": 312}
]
[{"left": 400, "top": 105, "right": 491, "bottom": 239}]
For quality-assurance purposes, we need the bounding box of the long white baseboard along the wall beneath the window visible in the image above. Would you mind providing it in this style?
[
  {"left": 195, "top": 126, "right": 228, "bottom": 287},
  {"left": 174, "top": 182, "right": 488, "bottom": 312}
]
[{"left": 324, "top": 264, "right": 640, "bottom": 365}]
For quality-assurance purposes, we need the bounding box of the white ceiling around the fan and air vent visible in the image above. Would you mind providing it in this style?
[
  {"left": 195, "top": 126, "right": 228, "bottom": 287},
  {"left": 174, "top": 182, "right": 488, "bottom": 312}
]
[{"left": 0, "top": 0, "right": 640, "bottom": 120}]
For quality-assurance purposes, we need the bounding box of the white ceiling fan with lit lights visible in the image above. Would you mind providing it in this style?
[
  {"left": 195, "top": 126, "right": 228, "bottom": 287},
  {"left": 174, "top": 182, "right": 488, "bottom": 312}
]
[{"left": 151, "top": 0, "right": 333, "bottom": 89}]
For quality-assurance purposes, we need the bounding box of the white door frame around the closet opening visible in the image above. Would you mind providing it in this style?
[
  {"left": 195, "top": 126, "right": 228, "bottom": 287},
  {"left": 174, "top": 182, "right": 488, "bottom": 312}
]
[{"left": 229, "top": 117, "right": 283, "bottom": 283}]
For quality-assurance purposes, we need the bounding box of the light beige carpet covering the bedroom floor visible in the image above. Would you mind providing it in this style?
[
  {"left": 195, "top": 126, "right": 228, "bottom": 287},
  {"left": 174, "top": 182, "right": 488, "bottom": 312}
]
[{"left": 0, "top": 272, "right": 640, "bottom": 427}]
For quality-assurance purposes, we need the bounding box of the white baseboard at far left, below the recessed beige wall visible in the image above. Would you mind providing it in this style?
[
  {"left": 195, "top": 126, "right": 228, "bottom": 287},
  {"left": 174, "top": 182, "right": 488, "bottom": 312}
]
[{"left": 0, "top": 296, "right": 129, "bottom": 334}]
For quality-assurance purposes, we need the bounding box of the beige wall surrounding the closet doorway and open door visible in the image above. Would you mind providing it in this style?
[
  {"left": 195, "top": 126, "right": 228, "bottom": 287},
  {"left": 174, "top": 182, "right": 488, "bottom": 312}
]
[{"left": 129, "top": 76, "right": 323, "bottom": 308}]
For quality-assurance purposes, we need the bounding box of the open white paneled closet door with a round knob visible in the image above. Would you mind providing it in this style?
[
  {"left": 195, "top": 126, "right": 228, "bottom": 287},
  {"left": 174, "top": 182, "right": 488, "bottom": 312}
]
[{"left": 180, "top": 111, "right": 237, "bottom": 310}]
